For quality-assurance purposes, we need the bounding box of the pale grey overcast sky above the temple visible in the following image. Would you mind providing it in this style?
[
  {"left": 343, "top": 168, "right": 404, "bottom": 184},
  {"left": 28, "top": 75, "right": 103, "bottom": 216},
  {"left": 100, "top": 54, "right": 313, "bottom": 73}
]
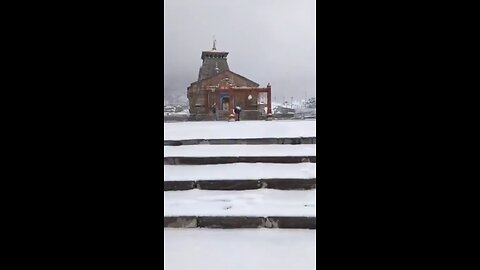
[{"left": 164, "top": 0, "right": 316, "bottom": 101}]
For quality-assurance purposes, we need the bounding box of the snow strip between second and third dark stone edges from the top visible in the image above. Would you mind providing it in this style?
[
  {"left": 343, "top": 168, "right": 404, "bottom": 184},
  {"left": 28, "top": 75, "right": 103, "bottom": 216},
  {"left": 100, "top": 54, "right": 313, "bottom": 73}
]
[{"left": 163, "top": 163, "right": 317, "bottom": 181}]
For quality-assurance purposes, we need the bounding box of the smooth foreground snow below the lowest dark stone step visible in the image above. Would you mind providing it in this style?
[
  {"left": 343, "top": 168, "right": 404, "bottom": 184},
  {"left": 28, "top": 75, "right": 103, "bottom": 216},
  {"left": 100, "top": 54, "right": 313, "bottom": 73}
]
[{"left": 164, "top": 228, "right": 316, "bottom": 270}]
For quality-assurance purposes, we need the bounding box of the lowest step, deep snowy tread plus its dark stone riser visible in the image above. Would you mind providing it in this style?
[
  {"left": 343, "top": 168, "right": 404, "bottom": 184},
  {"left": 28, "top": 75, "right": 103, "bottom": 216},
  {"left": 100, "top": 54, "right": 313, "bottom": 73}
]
[{"left": 164, "top": 189, "right": 316, "bottom": 229}]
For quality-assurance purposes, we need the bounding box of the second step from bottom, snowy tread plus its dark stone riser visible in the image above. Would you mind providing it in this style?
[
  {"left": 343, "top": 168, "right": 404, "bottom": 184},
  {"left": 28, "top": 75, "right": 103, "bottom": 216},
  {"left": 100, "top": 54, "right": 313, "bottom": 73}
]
[{"left": 163, "top": 163, "right": 316, "bottom": 191}]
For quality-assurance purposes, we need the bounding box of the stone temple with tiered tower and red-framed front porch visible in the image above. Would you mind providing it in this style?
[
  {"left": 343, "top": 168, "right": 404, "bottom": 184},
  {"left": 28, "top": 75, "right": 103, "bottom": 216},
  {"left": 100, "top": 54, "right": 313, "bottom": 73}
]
[{"left": 187, "top": 41, "right": 272, "bottom": 120}]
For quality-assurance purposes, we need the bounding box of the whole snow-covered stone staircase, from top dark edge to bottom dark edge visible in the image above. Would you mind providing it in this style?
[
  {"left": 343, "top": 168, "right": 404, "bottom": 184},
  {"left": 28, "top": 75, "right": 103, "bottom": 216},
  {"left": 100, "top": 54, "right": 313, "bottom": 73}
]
[{"left": 164, "top": 130, "right": 316, "bottom": 229}]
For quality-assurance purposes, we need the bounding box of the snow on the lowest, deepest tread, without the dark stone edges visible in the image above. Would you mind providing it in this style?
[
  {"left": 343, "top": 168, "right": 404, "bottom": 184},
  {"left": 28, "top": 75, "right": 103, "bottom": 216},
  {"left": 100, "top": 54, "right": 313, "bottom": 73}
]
[{"left": 163, "top": 189, "right": 316, "bottom": 217}]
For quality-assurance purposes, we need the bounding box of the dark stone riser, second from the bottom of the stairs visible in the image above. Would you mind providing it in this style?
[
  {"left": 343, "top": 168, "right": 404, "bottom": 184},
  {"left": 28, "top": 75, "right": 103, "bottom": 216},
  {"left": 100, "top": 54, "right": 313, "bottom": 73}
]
[{"left": 163, "top": 178, "right": 317, "bottom": 191}]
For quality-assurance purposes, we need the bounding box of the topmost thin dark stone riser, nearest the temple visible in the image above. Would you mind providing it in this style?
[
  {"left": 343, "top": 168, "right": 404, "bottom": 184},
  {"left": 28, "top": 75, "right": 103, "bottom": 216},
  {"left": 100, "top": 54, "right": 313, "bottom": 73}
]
[{"left": 163, "top": 137, "right": 317, "bottom": 146}]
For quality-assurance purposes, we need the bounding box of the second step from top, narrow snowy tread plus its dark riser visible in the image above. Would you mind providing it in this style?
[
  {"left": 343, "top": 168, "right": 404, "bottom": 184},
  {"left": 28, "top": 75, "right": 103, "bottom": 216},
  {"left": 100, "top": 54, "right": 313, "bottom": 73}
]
[{"left": 163, "top": 144, "right": 316, "bottom": 165}]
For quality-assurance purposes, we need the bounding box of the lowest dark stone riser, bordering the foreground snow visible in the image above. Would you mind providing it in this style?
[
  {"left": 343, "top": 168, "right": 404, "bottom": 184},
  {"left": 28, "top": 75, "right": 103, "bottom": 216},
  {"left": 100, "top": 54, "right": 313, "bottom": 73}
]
[{"left": 163, "top": 216, "right": 317, "bottom": 229}]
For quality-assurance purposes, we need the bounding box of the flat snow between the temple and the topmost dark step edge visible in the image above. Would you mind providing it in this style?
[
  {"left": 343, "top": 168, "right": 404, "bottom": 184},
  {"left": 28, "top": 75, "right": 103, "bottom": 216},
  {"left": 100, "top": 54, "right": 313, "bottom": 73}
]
[{"left": 163, "top": 120, "right": 316, "bottom": 140}]
